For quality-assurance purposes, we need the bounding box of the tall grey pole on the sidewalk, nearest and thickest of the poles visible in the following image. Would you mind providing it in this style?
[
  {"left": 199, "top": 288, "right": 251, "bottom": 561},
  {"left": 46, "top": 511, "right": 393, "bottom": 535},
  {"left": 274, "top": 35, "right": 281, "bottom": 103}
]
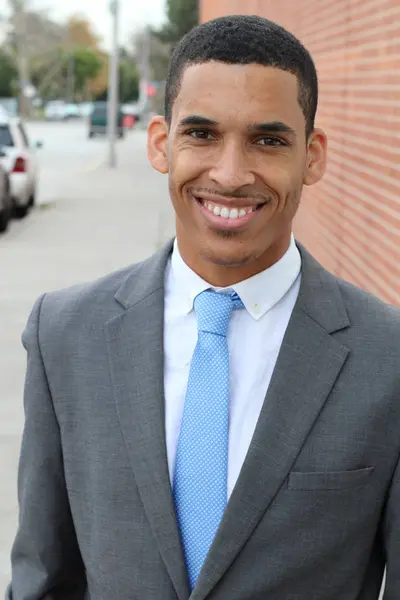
[{"left": 108, "top": 0, "right": 119, "bottom": 168}]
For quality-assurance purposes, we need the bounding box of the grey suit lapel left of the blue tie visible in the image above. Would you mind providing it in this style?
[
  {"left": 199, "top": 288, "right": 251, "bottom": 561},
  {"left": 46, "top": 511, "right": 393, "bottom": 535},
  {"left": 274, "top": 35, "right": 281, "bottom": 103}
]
[{"left": 106, "top": 245, "right": 189, "bottom": 600}]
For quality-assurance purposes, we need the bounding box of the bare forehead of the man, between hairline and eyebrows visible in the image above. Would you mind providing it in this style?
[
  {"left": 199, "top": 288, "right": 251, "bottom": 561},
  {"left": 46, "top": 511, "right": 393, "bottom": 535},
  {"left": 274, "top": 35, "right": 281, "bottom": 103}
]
[{"left": 173, "top": 62, "right": 305, "bottom": 129}]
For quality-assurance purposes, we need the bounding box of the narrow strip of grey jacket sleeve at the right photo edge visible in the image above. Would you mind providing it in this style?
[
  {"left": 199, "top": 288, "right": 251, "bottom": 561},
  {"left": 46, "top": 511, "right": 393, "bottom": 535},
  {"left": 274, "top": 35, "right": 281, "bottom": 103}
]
[{"left": 383, "top": 452, "right": 400, "bottom": 600}]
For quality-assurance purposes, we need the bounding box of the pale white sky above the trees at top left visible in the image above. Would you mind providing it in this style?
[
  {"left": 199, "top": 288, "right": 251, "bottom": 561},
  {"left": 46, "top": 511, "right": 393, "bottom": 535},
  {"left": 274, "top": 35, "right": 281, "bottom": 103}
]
[{"left": 0, "top": 0, "right": 166, "bottom": 48}]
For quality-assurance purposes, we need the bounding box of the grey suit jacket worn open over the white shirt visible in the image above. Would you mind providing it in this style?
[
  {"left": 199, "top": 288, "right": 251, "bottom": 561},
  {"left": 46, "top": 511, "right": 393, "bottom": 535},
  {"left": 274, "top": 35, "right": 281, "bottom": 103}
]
[{"left": 7, "top": 244, "right": 400, "bottom": 600}]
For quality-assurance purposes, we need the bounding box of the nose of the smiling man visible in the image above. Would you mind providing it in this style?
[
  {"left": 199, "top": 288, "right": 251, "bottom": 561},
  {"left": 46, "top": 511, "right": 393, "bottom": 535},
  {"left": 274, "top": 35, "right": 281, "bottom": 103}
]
[{"left": 210, "top": 142, "right": 255, "bottom": 190}]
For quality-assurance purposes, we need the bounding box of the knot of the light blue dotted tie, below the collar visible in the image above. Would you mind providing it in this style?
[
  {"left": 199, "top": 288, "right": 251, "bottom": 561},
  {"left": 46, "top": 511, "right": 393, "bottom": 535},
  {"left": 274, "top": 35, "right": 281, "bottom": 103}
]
[{"left": 194, "top": 290, "right": 244, "bottom": 336}]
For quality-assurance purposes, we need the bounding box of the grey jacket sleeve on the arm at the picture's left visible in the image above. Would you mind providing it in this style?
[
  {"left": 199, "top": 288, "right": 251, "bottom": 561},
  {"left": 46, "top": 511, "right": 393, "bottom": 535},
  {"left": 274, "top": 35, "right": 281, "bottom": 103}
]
[{"left": 6, "top": 296, "right": 86, "bottom": 600}]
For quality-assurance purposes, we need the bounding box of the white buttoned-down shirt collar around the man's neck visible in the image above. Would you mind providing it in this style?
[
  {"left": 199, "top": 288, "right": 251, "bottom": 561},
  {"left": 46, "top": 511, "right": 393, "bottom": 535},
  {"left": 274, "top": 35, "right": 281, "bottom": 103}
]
[{"left": 169, "top": 236, "right": 301, "bottom": 321}]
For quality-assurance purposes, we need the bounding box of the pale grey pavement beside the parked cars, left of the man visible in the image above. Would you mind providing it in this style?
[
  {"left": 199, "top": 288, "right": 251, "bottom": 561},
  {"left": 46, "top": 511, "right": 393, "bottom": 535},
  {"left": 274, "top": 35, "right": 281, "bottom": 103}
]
[{"left": 0, "top": 123, "right": 173, "bottom": 597}]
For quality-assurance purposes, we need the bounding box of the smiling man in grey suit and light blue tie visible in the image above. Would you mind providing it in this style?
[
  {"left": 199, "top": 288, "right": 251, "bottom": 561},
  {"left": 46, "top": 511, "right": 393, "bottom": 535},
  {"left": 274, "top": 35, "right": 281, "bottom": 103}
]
[{"left": 7, "top": 16, "right": 400, "bottom": 600}]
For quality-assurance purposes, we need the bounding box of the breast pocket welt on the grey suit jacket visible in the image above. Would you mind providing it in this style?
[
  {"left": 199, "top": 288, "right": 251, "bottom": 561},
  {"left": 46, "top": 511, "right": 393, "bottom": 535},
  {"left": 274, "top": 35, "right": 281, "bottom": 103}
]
[{"left": 288, "top": 467, "right": 374, "bottom": 491}]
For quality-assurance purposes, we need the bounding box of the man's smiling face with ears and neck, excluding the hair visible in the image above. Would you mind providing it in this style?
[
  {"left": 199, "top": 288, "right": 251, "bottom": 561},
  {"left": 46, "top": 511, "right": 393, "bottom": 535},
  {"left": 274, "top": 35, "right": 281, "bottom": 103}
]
[{"left": 148, "top": 62, "right": 326, "bottom": 286}]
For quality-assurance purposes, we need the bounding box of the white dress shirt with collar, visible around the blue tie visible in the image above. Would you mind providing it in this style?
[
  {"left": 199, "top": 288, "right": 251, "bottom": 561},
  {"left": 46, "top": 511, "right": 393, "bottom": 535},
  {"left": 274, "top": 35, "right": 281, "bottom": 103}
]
[{"left": 164, "top": 238, "right": 301, "bottom": 497}]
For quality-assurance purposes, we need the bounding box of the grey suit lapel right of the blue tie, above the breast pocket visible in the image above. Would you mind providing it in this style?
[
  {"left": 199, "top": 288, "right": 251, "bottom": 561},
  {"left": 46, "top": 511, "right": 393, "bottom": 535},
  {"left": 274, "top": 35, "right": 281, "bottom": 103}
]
[{"left": 191, "top": 247, "right": 349, "bottom": 600}]
